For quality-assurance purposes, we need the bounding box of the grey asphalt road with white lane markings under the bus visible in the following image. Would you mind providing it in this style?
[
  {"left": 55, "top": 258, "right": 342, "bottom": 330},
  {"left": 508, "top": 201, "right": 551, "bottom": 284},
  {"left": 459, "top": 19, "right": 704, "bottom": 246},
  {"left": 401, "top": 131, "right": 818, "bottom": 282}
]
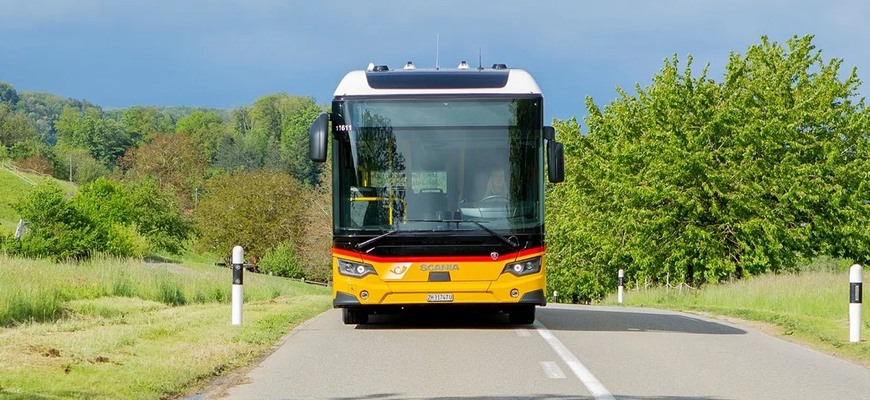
[{"left": 200, "top": 305, "right": 870, "bottom": 400}]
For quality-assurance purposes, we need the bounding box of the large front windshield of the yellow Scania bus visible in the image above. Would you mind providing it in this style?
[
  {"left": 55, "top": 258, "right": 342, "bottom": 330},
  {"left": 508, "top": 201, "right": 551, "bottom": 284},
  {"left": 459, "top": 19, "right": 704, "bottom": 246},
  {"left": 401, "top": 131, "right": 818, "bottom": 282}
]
[{"left": 332, "top": 96, "right": 543, "bottom": 234}]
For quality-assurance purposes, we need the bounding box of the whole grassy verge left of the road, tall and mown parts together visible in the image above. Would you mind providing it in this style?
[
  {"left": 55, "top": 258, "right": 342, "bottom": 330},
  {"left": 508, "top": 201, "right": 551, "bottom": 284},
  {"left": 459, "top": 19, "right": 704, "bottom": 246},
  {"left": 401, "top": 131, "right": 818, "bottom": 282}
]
[{"left": 0, "top": 256, "right": 330, "bottom": 399}]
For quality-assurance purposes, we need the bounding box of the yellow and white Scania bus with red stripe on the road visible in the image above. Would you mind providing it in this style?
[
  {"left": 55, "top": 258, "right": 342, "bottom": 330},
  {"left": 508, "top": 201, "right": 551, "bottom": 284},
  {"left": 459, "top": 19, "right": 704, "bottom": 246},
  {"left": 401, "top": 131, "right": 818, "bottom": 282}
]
[{"left": 309, "top": 62, "right": 564, "bottom": 324}]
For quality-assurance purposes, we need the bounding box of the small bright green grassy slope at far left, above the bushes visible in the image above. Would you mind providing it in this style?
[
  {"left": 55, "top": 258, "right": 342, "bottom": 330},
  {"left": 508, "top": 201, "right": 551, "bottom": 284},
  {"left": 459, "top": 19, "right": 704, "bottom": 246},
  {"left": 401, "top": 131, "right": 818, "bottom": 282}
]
[{"left": 0, "top": 163, "right": 78, "bottom": 235}]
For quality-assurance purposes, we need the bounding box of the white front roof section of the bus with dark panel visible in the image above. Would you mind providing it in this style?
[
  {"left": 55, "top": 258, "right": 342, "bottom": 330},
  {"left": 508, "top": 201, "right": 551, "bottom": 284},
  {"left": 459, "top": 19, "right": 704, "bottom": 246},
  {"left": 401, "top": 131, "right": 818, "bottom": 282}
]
[{"left": 334, "top": 65, "right": 541, "bottom": 98}]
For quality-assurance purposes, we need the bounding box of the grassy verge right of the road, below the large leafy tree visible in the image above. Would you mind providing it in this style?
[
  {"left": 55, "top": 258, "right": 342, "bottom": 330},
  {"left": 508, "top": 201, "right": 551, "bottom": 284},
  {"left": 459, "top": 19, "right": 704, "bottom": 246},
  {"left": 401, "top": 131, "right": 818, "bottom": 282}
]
[{"left": 605, "top": 268, "right": 870, "bottom": 367}]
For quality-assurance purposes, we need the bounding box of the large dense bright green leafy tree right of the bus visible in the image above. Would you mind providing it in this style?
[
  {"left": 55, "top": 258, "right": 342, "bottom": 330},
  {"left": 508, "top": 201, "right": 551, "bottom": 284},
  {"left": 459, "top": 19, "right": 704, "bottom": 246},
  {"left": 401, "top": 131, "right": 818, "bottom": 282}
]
[{"left": 547, "top": 36, "right": 870, "bottom": 299}]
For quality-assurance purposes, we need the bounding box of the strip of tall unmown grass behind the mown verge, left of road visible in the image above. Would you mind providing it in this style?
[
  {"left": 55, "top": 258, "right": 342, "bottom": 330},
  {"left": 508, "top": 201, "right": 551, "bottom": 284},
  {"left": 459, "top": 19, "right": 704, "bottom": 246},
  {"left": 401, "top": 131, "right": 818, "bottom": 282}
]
[{"left": 0, "top": 255, "right": 324, "bottom": 326}]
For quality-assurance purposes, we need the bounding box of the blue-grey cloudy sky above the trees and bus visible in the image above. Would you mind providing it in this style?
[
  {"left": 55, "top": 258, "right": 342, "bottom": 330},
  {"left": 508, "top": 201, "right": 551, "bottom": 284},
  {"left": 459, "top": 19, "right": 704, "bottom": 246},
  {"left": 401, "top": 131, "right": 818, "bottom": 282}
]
[{"left": 0, "top": 0, "right": 870, "bottom": 122}]
